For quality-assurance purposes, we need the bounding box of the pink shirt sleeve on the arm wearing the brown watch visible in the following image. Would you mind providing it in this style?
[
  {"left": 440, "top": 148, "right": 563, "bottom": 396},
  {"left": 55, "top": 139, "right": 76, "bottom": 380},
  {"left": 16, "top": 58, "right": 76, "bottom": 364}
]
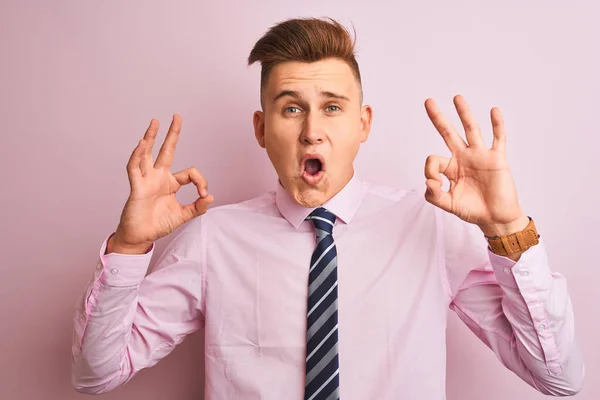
[{"left": 436, "top": 209, "right": 584, "bottom": 396}]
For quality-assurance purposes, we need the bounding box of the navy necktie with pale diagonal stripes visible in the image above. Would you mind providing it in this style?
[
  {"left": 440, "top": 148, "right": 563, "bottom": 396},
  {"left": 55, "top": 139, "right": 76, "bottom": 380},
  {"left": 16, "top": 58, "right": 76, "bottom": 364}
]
[{"left": 304, "top": 207, "right": 340, "bottom": 400}]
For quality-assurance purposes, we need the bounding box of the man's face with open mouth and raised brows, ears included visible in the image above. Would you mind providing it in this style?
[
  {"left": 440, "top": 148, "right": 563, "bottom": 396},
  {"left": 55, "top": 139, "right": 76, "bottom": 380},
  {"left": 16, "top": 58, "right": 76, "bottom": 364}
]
[{"left": 254, "top": 59, "right": 372, "bottom": 207}]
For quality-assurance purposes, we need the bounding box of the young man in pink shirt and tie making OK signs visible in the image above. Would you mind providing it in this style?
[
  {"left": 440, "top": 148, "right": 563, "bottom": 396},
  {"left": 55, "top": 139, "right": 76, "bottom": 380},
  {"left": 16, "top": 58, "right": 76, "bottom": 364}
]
[{"left": 73, "top": 19, "right": 584, "bottom": 400}]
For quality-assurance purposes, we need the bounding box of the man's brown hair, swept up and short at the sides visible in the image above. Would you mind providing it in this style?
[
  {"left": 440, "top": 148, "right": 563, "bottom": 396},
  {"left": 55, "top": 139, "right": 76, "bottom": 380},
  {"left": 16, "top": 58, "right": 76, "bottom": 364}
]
[{"left": 248, "top": 18, "right": 362, "bottom": 103}]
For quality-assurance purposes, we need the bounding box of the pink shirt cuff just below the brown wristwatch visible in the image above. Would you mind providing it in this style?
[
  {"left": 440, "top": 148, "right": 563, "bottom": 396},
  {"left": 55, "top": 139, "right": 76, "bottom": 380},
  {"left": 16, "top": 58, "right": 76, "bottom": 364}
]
[{"left": 488, "top": 238, "right": 552, "bottom": 292}]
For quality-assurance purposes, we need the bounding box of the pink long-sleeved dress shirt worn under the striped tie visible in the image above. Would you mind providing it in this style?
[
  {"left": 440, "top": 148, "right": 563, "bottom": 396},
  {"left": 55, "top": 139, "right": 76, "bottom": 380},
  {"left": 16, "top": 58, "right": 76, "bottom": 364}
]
[{"left": 72, "top": 175, "right": 584, "bottom": 400}]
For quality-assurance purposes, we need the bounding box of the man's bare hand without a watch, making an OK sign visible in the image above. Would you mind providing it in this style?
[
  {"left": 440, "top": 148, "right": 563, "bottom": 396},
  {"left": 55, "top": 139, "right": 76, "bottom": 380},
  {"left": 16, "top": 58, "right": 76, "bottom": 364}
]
[{"left": 106, "top": 114, "right": 214, "bottom": 254}]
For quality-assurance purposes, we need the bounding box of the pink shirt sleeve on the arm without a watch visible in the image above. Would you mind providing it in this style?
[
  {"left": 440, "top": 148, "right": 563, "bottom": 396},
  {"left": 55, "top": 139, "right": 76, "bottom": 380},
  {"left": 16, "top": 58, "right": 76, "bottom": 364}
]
[{"left": 71, "top": 218, "right": 204, "bottom": 394}]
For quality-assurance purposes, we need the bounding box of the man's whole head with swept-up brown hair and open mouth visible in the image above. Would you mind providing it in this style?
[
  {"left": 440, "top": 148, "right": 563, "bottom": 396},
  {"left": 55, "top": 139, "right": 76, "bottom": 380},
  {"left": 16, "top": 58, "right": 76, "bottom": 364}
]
[{"left": 248, "top": 18, "right": 372, "bottom": 207}]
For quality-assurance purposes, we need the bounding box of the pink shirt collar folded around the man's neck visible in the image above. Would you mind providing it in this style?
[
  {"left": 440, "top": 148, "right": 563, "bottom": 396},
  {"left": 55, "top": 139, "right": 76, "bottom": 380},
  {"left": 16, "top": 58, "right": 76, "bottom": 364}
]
[{"left": 275, "top": 172, "right": 364, "bottom": 228}]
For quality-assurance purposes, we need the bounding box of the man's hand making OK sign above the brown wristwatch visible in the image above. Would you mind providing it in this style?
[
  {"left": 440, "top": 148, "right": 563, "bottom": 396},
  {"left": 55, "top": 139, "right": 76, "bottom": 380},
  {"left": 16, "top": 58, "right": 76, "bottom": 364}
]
[{"left": 425, "top": 95, "right": 529, "bottom": 236}]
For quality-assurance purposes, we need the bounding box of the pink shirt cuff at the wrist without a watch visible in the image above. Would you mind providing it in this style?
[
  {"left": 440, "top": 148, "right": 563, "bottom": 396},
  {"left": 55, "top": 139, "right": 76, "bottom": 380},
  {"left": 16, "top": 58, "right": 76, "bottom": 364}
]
[{"left": 97, "top": 234, "right": 154, "bottom": 286}]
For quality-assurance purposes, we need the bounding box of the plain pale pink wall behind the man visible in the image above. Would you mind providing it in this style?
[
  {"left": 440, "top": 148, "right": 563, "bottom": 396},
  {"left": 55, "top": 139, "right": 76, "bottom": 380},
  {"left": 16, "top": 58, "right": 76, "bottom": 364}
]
[{"left": 0, "top": 0, "right": 600, "bottom": 400}]
